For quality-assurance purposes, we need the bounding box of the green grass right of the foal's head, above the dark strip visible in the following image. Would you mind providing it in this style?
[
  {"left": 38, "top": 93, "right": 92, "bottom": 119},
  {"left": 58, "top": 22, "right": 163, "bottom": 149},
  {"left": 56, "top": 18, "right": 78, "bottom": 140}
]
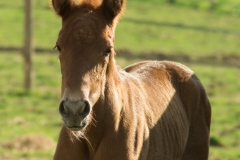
[{"left": 116, "top": 1, "right": 240, "bottom": 56}]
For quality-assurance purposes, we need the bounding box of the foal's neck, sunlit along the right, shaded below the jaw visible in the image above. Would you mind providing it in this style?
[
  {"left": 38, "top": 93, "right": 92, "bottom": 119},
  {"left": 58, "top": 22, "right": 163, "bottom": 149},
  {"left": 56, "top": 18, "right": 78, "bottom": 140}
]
[{"left": 85, "top": 55, "right": 122, "bottom": 154}]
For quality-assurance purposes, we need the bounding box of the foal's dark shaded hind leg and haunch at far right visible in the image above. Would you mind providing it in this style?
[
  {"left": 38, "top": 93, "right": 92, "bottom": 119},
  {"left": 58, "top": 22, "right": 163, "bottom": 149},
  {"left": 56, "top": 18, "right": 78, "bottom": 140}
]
[{"left": 178, "top": 76, "right": 211, "bottom": 160}]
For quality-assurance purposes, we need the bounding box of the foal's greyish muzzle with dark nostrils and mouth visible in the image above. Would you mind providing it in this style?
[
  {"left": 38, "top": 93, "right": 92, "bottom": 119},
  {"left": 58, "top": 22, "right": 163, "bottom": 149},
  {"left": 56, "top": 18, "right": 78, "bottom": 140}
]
[{"left": 59, "top": 100, "right": 91, "bottom": 131}]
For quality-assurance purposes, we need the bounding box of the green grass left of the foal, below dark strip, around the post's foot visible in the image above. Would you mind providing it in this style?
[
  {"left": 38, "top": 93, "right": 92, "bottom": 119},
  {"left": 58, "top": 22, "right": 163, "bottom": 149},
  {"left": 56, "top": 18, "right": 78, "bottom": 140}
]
[{"left": 0, "top": 53, "right": 61, "bottom": 159}]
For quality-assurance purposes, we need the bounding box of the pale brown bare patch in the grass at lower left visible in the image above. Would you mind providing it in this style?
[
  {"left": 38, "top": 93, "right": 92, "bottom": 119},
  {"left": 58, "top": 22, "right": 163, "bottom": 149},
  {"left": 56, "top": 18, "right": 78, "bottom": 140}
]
[{"left": 0, "top": 134, "right": 55, "bottom": 152}]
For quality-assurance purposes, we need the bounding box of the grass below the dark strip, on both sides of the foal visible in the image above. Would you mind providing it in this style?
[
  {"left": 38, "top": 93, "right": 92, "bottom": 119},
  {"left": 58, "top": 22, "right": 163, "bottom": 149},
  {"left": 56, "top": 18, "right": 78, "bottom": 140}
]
[{"left": 0, "top": 53, "right": 240, "bottom": 160}]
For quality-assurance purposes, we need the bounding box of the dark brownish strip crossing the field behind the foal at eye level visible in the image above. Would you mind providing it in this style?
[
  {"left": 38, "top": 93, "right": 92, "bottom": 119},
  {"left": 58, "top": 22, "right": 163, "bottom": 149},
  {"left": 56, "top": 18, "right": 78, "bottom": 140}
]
[{"left": 0, "top": 46, "right": 240, "bottom": 68}]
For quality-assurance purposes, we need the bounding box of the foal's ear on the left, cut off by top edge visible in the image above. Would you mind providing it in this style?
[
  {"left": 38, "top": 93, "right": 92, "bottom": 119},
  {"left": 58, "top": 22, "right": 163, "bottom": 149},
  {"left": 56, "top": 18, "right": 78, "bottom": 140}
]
[{"left": 51, "top": 0, "right": 76, "bottom": 17}]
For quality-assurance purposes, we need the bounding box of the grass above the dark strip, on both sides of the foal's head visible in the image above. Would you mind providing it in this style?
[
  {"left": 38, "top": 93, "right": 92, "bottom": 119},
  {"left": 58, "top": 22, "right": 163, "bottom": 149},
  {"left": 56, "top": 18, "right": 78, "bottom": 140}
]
[{"left": 0, "top": 0, "right": 240, "bottom": 57}]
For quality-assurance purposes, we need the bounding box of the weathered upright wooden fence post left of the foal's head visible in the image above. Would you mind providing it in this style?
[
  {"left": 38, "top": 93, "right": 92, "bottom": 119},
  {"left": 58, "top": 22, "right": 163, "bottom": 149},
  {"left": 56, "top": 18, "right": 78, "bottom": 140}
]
[{"left": 23, "top": 0, "right": 34, "bottom": 90}]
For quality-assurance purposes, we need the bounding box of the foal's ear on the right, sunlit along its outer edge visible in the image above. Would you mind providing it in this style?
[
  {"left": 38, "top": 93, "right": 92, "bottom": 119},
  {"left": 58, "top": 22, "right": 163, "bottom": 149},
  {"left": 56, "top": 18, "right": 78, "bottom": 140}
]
[{"left": 101, "top": 0, "right": 126, "bottom": 20}]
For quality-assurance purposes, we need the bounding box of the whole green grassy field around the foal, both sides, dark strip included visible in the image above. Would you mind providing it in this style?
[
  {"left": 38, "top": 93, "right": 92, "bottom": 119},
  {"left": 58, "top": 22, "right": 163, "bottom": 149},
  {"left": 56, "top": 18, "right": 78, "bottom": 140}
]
[{"left": 0, "top": 0, "right": 240, "bottom": 160}]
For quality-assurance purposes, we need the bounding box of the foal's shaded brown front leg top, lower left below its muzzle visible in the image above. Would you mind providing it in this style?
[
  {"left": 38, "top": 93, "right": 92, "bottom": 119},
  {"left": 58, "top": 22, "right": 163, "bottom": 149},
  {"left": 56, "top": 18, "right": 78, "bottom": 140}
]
[{"left": 53, "top": 126, "right": 89, "bottom": 160}]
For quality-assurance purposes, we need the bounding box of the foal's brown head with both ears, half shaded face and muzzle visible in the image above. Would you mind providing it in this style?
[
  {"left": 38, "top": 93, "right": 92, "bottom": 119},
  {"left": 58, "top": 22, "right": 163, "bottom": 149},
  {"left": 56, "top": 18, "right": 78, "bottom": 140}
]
[{"left": 52, "top": 0, "right": 124, "bottom": 131}]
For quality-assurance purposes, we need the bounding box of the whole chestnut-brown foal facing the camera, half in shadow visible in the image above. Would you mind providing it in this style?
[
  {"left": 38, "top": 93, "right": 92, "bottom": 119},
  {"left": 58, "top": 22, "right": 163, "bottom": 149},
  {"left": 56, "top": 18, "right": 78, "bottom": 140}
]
[{"left": 52, "top": 0, "right": 211, "bottom": 160}]
